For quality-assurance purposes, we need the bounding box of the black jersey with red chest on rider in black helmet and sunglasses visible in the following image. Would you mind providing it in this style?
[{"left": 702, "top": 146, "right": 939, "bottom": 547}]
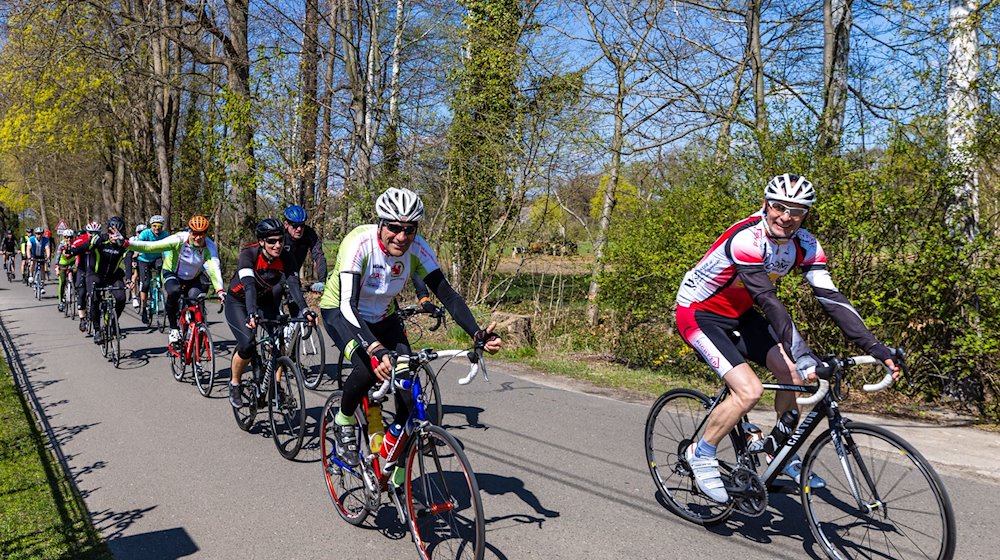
[{"left": 227, "top": 243, "right": 306, "bottom": 315}]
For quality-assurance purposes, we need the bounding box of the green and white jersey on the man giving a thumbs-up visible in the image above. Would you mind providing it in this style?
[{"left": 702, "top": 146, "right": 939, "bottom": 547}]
[{"left": 319, "top": 224, "right": 441, "bottom": 323}]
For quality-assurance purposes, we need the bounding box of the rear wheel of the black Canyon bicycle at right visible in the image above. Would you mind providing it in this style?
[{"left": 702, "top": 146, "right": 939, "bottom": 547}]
[{"left": 643, "top": 389, "right": 739, "bottom": 526}]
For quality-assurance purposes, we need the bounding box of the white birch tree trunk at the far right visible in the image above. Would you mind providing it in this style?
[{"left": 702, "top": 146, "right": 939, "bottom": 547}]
[{"left": 945, "top": 0, "right": 979, "bottom": 241}]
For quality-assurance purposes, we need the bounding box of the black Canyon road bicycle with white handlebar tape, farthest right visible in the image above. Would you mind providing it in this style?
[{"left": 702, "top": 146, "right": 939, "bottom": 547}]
[{"left": 644, "top": 351, "right": 956, "bottom": 560}]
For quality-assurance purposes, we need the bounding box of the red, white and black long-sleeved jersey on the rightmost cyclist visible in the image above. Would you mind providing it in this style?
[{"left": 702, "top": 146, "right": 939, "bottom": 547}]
[{"left": 677, "top": 211, "right": 881, "bottom": 361}]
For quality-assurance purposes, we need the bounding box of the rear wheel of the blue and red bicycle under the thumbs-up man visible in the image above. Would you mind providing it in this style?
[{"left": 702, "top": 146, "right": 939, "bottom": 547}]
[{"left": 320, "top": 391, "right": 374, "bottom": 525}]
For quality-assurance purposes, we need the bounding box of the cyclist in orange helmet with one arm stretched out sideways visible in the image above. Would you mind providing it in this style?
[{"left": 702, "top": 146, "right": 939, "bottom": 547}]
[{"left": 129, "top": 214, "right": 224, "bottom": 344}]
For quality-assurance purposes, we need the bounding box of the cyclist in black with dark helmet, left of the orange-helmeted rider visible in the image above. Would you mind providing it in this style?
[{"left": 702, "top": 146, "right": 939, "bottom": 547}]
[{"left": 67, "top": 216, "right": 128, "bottom": 344}]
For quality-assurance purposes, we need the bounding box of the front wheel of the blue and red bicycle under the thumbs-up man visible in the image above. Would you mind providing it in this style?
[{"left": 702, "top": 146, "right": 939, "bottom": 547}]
[{"left": 404, "top": 424, "right": 486, "bottom": 560}]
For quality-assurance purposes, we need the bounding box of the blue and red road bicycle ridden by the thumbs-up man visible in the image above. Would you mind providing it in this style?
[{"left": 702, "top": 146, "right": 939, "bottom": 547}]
[{"left": 320, "top": 343, "right": 486, "bottom": 560}]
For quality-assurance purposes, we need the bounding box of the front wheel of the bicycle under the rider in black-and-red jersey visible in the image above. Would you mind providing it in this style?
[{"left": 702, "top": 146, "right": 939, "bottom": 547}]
[{"left": 267, "top": 356, "right": 306, "bottom": 459}]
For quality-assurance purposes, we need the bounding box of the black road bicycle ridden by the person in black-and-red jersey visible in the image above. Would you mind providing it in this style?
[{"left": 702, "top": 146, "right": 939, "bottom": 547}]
[{"left": 233, "top": 314, "right": 306, "bottom": 459}]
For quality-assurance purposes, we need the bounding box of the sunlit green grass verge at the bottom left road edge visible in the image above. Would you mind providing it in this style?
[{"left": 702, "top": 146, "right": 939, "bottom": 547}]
[{"left": 0, "top": 359, "right": 111, "bottom": 560}]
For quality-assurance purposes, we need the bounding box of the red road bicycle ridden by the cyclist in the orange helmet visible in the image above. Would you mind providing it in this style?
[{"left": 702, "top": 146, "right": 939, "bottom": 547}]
[{"left": 170, "top": 294, "right": 215, "bottom": 397}]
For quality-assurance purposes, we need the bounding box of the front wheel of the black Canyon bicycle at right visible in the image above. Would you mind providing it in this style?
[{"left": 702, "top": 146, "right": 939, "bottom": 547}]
[{"left": 800, "top": 420, "right": 956, "bottom": 560}]
